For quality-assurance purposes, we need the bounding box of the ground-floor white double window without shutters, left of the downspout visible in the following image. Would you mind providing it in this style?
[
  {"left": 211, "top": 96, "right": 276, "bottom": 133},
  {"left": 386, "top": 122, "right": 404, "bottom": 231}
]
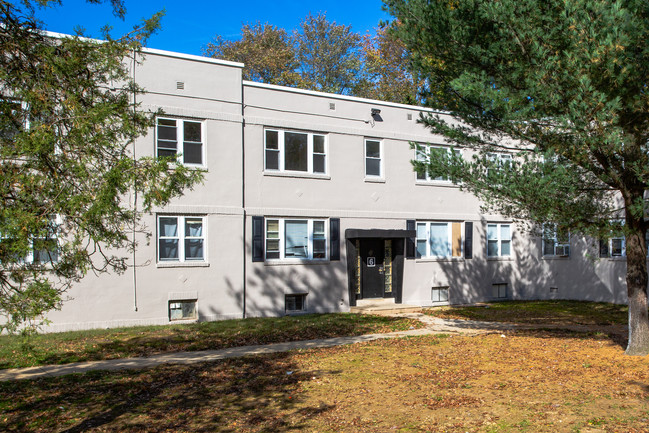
[{"left": 158, "top": 215, "right": 205, "bottom": 262}]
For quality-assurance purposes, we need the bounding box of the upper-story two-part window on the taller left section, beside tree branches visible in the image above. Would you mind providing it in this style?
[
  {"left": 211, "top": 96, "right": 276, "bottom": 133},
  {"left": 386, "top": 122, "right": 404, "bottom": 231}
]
[{"left": 156, "top": 117, "right": 205, "bottom": 166}]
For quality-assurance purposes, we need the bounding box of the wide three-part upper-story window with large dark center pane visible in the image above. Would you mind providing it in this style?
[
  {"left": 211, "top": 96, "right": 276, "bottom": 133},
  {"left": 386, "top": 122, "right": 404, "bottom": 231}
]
[{"left": 264, "top": 129, "right": 327, "bottom": 174}]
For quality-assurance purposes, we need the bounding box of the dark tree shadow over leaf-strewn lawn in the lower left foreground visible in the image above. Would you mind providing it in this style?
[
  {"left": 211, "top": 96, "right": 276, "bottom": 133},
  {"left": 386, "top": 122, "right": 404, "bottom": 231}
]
[{"left": 0, "top": 354, "right": 337, "bottom": 433}]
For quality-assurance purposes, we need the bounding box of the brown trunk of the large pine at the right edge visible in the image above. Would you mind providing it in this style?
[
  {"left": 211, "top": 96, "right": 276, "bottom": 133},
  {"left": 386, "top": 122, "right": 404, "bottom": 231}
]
[{"left": 626, "top": 219, "right": 649, "bottom": 356}]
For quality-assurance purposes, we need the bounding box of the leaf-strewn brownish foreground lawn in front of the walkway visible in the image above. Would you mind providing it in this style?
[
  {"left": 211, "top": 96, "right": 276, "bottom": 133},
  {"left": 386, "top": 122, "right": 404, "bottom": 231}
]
[{"left": 0, "top": 331, "right": 649, "bottom": 432}]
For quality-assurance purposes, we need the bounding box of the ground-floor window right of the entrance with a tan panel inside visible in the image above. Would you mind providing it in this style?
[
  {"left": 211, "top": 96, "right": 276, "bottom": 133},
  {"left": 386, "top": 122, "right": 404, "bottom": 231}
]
[{"left": 417, "top": 221, "right": 463, "bottom": 258}]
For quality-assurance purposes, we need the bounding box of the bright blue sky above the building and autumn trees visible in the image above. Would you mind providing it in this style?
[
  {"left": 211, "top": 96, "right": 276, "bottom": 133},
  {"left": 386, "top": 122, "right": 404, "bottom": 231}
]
[{"left": 37, "top": 0, "right": 390, "bottom": 55}]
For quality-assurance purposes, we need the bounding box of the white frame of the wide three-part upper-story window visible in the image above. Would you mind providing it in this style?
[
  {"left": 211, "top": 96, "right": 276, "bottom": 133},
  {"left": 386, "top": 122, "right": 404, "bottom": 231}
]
[{"left": 264, "top": 128, "right": 329, "bottom": 176}]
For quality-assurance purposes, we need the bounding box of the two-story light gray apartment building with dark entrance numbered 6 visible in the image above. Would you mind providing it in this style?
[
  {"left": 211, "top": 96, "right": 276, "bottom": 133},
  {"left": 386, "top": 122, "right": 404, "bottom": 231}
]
[{"left": 41, "top": 46, "right": 626, "bottom": 331}]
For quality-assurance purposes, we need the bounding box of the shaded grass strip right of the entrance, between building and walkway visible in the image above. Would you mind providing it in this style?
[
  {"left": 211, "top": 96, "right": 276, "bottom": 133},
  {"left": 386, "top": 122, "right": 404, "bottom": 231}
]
[{"left": 424, "top": 301, "right": 629, "bottom": 325}]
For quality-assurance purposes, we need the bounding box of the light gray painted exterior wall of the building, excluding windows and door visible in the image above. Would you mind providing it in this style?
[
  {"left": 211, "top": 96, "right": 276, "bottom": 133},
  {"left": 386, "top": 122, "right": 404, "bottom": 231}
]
[{"left": 38, "top": 46, "right": 626, "bottom": 331}]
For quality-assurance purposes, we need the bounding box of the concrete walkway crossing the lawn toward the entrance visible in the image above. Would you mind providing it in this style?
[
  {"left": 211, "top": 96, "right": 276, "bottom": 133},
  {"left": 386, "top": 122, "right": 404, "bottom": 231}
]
[{"left": 0, "top": 313, "right": 608, "bottom": 381}]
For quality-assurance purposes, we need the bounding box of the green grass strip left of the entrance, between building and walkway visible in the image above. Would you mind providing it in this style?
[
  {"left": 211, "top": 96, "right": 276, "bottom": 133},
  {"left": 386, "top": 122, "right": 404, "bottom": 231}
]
[{"left": 0, "top": 313, "right": 423, "bottom": 368}]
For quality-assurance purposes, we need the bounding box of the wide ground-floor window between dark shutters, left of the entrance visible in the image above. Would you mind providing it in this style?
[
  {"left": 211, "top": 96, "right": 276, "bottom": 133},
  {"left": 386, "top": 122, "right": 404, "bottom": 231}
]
[{"left": 266, "top": 218, "right": 328, "bottom": 260}]
